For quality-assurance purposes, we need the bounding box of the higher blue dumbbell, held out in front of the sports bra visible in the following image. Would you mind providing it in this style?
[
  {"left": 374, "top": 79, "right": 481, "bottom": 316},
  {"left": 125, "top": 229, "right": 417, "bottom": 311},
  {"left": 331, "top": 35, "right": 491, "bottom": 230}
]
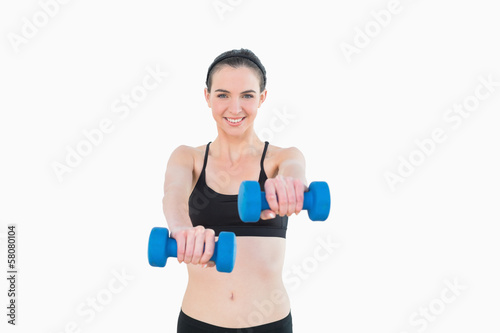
[{"left": 238, "top": 180, "right": 330, "bottom": 222}]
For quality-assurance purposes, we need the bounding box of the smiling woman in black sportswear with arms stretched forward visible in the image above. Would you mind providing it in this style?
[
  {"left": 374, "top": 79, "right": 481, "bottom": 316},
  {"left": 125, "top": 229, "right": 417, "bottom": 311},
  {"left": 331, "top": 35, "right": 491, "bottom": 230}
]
[{"left": 163, "top": 49, "right": 306, "bottom": 333}]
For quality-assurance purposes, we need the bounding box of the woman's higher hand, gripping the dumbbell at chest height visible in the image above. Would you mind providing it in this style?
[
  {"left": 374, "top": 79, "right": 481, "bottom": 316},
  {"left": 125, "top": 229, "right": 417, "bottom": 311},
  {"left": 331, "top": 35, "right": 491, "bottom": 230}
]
[{"left": 260, "top": 176, "right": 307, "bottom": 220}]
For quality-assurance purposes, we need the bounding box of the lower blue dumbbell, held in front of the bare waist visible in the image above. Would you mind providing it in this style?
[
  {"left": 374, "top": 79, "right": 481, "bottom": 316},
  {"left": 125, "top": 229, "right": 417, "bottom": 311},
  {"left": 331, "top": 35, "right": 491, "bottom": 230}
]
[{"left": 148, "top": 227, "right": 236, "bottom": 273}]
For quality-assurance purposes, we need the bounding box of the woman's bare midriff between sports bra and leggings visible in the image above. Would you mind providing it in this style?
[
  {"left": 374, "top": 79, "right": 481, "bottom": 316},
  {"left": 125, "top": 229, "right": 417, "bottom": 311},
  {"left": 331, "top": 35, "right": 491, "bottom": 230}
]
[{"left": 182, "top": 237, "right": 290, "bottom": 328}]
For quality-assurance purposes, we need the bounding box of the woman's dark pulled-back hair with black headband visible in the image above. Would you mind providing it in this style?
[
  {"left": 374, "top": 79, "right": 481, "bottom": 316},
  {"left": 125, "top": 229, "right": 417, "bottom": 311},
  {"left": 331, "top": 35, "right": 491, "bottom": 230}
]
[{"left": 205, "top": 49, "right": 267, "bottom": 92}]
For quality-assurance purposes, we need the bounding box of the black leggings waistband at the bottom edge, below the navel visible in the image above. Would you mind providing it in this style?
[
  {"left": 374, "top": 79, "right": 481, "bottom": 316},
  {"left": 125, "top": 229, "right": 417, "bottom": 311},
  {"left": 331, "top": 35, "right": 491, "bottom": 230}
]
[{"left": 177, "top": 310, "right": 293, "bottom": 333}]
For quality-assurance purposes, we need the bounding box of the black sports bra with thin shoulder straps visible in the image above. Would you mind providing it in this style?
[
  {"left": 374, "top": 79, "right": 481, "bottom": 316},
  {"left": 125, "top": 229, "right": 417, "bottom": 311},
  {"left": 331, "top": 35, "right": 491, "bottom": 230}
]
[{"left": 188, "top": 141, "right": 288, "bottom": 238}]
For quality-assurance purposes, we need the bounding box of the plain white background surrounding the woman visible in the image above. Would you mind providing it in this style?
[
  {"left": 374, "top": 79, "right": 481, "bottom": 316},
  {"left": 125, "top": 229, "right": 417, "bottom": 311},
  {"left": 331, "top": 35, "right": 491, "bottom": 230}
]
[{"left": 0, "top": 0, "right": 500, "bottom": 333}]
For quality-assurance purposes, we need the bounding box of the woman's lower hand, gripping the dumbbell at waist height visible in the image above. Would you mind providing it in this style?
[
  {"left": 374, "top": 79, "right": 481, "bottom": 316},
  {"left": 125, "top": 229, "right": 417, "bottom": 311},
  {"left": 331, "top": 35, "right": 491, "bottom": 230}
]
[{"left": 171, "top": 226, "right": 215, "bottom": 267}]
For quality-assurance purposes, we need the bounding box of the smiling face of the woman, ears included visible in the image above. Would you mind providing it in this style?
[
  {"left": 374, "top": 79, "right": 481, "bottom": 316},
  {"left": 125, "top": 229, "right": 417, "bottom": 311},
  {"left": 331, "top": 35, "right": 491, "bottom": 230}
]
[{"left": 205, "top": 66, "right": 267, "bottom": 135}]
